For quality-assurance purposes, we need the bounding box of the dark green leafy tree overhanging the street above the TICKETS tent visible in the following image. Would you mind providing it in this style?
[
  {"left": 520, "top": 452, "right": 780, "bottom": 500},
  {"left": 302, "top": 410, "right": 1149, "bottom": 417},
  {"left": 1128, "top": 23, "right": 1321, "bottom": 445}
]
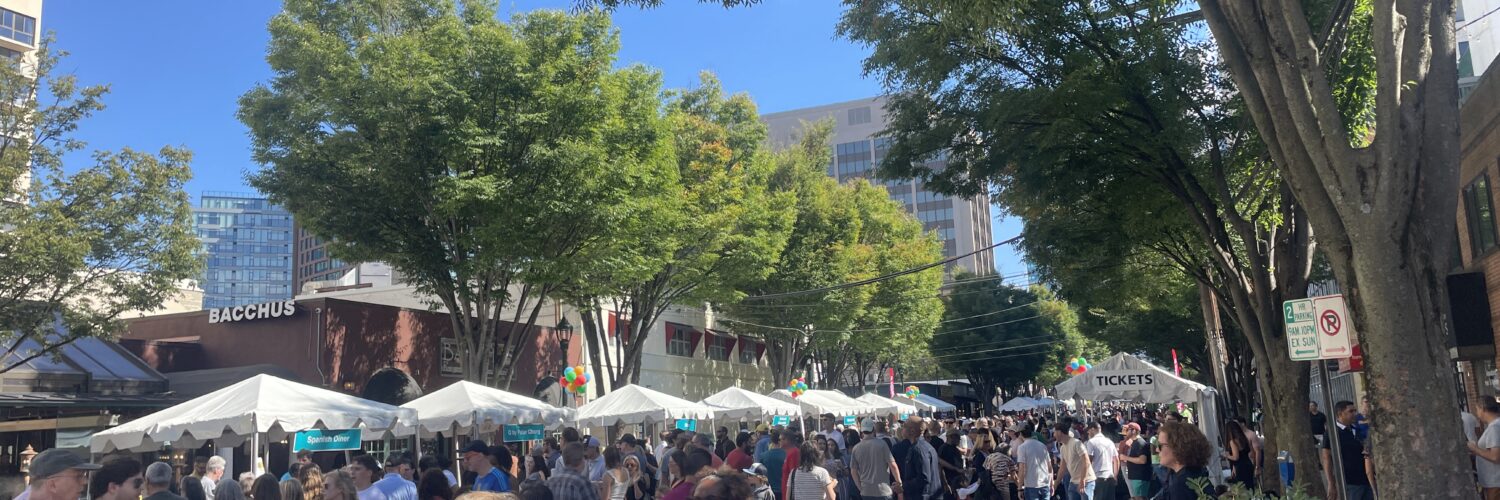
[{"left": 842, "top": 0, "right": 1338, "bottom": 491}]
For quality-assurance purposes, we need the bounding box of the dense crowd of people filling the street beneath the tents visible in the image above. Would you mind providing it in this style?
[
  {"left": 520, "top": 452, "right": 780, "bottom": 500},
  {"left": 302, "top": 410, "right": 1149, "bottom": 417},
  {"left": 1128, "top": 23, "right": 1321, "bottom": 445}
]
[{"left": 18, "top": 408, "right": 1242, "bottom": 500}]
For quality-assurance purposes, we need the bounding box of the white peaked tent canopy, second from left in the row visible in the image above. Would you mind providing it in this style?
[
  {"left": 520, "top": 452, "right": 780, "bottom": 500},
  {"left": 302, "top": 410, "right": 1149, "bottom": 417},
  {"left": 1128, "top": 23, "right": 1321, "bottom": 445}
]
[{"left": 401, "top": 380, "right": 573, "bottom": 435}]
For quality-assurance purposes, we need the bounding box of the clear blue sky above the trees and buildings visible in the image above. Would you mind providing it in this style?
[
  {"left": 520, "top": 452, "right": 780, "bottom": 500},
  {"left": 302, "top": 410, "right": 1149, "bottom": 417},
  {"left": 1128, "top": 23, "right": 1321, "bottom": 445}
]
[{"left": 42, "top": 0, "right": 1025, "bottom": 273}]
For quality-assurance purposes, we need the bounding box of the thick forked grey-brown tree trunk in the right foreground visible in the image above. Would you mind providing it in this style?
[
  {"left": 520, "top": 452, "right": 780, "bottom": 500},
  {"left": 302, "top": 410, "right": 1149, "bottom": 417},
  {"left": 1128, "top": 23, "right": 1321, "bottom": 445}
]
[{"left": 1199, "top": 0, "right": 1475, "bottom": 498}]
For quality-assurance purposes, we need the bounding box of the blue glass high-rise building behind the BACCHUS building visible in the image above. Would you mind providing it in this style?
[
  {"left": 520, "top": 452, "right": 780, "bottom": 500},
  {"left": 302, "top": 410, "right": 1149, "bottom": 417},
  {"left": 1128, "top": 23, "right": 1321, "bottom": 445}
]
[{"left": 194, "top": 192, "right": 293, "bottom": 309}]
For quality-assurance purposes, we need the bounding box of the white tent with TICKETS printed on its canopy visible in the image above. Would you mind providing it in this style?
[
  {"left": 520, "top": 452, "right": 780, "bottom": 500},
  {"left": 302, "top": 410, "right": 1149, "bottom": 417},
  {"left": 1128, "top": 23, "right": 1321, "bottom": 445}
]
[{"left": 1058, "top": 353, "right": 1223, "bottom": 483}]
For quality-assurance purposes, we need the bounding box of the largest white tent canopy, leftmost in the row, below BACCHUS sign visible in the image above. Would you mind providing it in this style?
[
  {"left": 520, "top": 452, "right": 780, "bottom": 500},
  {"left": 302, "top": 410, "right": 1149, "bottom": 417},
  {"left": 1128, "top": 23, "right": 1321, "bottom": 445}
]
[{"left": 89, "top": 374, "right": 417, "bottom": 453}]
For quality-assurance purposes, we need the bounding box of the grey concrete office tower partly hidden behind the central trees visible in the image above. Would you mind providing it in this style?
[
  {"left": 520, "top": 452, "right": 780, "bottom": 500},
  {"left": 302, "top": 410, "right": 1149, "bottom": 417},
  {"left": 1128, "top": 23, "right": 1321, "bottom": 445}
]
[{"left": 761, "top": 98, "right": 995, "bottom": 276}]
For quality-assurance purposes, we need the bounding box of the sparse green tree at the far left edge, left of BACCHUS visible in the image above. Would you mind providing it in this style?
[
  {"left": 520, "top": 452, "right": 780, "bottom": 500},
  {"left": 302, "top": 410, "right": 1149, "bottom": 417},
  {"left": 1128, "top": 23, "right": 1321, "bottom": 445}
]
[{"left": 0, "top": 35, "right": 203, "bottom": 372}]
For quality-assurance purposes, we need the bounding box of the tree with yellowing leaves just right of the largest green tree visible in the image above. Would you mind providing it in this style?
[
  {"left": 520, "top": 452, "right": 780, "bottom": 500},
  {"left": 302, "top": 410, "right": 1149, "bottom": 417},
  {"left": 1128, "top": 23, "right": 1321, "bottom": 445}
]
[{"left": 572, "top": 74, "right": 795, "bottom": 387}]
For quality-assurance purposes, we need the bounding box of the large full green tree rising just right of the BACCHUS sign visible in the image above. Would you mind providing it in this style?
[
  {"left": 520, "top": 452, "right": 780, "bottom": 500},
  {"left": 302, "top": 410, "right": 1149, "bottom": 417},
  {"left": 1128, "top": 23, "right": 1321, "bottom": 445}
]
[{"left": 240, "top": 0, "right": 675, "bottom": 387}]
